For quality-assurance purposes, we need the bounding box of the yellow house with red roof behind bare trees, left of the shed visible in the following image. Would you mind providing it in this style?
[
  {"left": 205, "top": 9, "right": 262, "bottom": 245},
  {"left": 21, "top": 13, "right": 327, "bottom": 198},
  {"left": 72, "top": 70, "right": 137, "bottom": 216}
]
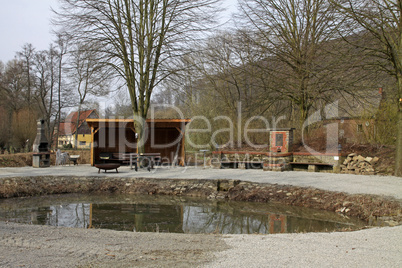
[{"left": 57, "top": 109, "right": 99, "bottom": 149}]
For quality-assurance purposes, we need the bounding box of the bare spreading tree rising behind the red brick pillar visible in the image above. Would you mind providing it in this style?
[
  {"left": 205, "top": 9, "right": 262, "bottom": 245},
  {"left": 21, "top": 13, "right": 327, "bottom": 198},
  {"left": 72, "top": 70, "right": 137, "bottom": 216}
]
[{"left": 240, "top": 0, "right": 370, "bottom": 130}]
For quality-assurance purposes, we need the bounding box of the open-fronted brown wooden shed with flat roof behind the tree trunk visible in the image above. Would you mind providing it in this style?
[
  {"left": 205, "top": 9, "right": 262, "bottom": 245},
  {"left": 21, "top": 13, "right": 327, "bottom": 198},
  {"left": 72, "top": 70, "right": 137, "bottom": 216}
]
[{"left": 86, "top": 119, "right": 190, "bottom": 165}]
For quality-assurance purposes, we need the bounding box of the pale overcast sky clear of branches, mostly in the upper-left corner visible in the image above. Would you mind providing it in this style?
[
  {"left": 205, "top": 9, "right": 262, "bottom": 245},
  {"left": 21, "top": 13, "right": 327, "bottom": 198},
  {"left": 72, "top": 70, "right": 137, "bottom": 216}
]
[{"left": 0, "top": 0, "right": 237, "bottom": 63}]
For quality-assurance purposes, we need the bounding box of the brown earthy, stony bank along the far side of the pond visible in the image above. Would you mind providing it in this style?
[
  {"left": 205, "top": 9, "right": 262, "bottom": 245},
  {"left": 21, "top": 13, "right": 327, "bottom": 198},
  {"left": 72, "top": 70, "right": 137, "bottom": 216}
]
[{"left": 0, "top": 176, "right": 402, "bottom": 226}]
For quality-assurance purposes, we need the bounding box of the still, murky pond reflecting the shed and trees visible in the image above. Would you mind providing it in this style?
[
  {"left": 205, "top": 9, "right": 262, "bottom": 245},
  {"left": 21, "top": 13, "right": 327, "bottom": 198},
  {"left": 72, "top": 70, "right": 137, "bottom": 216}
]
[{"left": 0, "top": 194, "right": 365, "bottom": 234}]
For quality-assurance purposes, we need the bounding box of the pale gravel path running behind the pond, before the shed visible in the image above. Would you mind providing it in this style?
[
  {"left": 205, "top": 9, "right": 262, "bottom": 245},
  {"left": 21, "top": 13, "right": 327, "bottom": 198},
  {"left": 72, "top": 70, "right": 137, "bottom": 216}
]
[{"left": 0, "top": 165, "right": 402, "bottom": 200}]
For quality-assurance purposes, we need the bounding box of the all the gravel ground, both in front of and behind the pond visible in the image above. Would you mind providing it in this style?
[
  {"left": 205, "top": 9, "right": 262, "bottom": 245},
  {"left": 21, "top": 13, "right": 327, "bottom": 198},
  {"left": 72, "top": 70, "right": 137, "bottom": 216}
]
[{"left": 0, "top": 165, "right": 402, "bottom": 267}]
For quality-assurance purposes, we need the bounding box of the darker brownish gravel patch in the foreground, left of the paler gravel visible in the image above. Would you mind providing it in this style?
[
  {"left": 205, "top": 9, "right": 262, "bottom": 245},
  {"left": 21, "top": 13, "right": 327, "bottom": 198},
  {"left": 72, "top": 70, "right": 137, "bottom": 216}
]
[{"left": 0, "top": 222, "right": 228, "bottom": 267}]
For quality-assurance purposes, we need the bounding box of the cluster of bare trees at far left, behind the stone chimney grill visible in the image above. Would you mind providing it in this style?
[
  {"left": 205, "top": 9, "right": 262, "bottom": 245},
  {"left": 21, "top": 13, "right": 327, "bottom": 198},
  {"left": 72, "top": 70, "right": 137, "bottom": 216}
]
[{"left": 0, "top": 37, "right": 110, "bottom": 152}]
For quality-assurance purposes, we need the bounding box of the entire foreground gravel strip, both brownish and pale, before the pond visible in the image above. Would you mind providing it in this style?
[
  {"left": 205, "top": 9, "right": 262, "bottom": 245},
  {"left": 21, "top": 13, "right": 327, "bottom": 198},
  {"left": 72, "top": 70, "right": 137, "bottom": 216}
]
[{"left": 0, "top": 222, "right": 402, "bottom": 267}]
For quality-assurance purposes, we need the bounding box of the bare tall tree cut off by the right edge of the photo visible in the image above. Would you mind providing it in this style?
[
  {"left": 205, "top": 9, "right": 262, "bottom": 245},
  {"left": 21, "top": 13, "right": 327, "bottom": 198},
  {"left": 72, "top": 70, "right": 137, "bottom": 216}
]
[{"left": 334, "top": 0, "right": 402, "bottom": 177}]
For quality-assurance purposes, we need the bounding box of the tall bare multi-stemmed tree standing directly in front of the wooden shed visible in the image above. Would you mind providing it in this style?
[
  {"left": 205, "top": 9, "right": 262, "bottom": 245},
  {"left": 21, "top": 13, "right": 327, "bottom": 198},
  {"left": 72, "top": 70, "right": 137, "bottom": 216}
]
[{"left": 54, "top": 0, "right": 218, "bottom": 152}]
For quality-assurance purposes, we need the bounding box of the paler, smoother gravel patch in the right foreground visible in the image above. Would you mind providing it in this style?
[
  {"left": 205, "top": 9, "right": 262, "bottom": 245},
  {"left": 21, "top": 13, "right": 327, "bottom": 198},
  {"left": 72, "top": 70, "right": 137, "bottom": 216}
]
[{"left": 205, "top": 226, "right": 402, "bottom": 268}]
